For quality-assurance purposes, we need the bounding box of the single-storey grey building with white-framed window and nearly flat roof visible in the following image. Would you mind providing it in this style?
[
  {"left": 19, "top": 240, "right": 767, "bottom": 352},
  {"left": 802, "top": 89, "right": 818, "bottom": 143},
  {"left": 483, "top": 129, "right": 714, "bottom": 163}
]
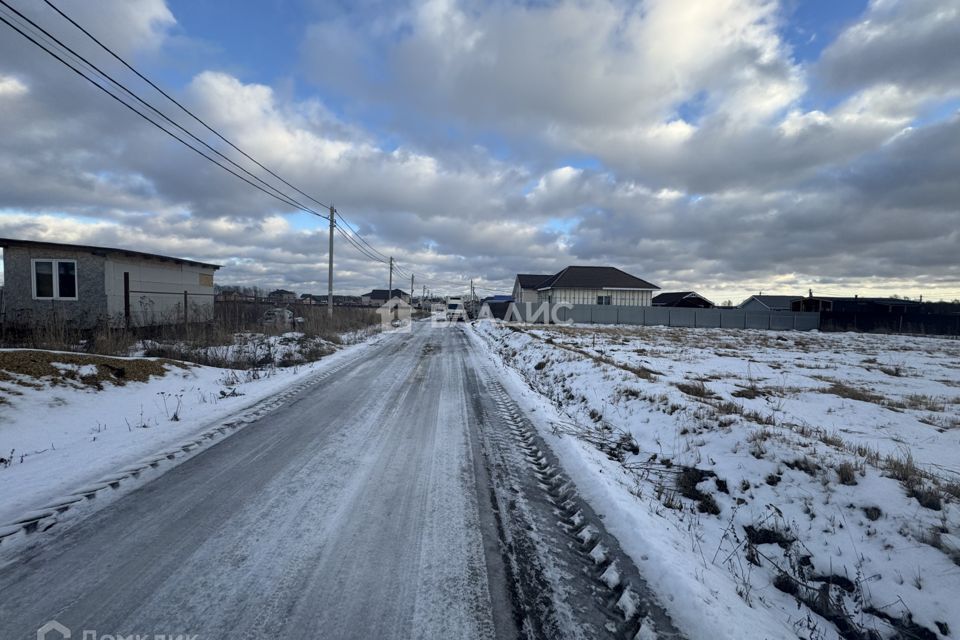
[{"left": 0, "top": 238, "right": 220, "bottom": 329}]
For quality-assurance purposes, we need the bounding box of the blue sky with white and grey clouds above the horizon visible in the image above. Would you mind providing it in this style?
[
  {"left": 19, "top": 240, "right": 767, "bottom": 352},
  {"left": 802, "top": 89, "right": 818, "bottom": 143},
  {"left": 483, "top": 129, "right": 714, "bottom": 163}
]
[{"left": 0, "top": 0, "right": 960, "bottom": 303}]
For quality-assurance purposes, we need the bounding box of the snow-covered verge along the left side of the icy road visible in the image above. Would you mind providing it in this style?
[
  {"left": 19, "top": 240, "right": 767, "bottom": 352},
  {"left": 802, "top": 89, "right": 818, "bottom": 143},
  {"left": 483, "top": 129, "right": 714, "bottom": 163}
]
[{"left": 0, "top": 334, "right": 378, "bottom": 525}]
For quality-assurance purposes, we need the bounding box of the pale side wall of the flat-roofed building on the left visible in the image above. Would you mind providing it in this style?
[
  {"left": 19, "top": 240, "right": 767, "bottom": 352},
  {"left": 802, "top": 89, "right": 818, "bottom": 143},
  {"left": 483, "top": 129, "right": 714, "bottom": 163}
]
[{"left": 104, "top": 256, "right": 214, "bottom": 326}]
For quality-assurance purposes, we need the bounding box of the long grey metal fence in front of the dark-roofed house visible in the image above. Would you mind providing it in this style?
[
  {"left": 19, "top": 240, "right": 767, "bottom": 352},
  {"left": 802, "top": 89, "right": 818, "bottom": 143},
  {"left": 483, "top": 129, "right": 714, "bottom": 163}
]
[{"left": 507, "top": 304, "right": 820, "bottom": 331}]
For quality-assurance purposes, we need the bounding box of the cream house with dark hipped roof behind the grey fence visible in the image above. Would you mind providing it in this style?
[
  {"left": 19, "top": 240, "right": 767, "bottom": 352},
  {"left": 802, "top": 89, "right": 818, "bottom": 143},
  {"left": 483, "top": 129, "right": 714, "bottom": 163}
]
[{"left": 535, "top": 267, "right": 660, "bottom": 307}]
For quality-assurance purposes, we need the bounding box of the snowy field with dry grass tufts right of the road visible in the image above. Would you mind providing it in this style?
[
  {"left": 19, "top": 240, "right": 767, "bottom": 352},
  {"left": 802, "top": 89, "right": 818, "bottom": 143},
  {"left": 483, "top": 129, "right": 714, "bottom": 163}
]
[{"left": 475, "top": 322, "right": 960, "bottom": 638}]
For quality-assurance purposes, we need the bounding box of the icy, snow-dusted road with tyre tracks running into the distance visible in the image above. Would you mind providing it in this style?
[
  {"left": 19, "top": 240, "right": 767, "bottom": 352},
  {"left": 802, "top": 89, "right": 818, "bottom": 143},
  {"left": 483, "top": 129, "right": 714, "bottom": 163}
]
[{"left": 0, "top": 323, "right": 672, "bottom": 640}]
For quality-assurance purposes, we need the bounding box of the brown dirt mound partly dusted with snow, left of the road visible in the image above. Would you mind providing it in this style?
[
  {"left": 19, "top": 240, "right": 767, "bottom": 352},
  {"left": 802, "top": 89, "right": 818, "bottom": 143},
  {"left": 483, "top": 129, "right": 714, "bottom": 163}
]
[{"left": 0, "top": 349, "right": 187, "bottom": 389}]
